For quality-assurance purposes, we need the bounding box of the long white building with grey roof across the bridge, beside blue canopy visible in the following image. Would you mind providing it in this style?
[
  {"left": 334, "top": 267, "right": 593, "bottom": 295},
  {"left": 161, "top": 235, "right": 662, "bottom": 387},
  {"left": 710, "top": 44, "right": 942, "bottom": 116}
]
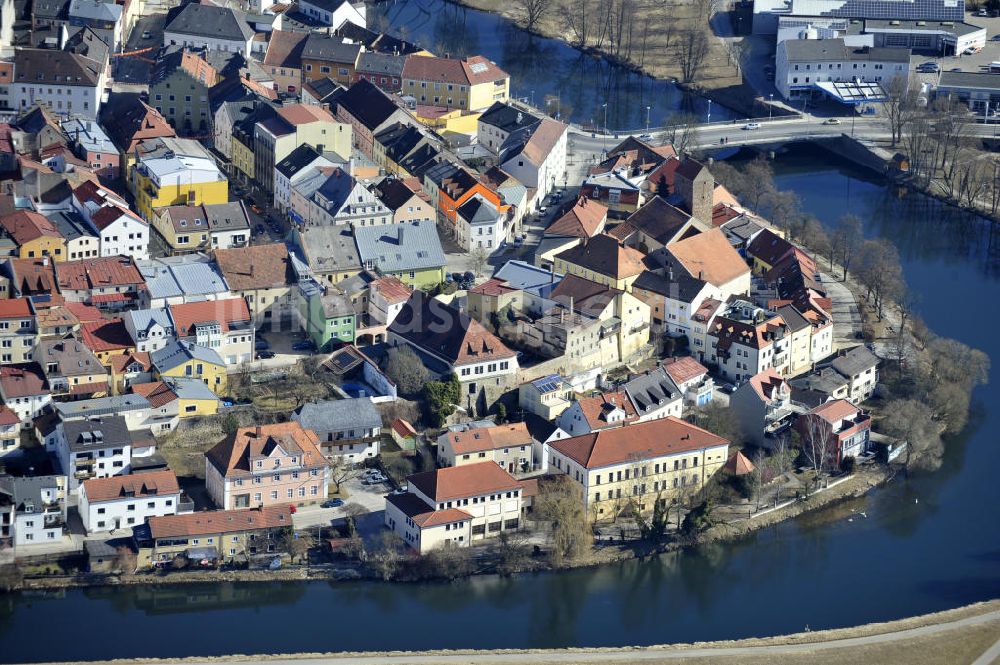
[{"left": 774, "top": 32, "right": 910, "bottom": 100}]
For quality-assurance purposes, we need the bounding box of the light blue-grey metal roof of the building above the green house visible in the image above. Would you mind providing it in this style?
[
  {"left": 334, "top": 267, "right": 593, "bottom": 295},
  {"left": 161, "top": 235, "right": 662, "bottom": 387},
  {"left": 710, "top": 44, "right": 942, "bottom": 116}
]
[{"left": 354, "top": 221, "right": 448, "bottom": 272}]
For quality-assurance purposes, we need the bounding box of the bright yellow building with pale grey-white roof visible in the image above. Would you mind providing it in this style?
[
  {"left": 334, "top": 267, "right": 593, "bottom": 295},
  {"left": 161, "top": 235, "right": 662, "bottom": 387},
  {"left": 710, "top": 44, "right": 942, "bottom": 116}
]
[{"left": 131, "top": 138, "right": 229, "bottom": 222}]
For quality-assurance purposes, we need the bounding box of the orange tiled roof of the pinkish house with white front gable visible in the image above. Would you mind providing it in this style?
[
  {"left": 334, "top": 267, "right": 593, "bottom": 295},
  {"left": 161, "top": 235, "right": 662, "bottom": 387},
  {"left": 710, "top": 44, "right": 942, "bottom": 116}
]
[{"left": 205, "top": 421, "right": 327, "bottom": 478}]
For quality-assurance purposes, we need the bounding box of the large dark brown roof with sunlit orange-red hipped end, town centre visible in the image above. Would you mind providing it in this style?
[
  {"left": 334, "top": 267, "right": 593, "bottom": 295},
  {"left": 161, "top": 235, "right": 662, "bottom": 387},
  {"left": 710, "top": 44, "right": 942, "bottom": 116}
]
[{"left": 389, "top": 291, "right": 515, "bottom": 366}]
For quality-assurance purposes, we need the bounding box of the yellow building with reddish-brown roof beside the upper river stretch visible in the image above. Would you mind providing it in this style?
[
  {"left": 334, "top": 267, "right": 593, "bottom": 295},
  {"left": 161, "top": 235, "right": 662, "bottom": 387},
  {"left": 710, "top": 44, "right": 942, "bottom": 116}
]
[{"left": 402, "top": 55, "right": 510, "bottom": 111}]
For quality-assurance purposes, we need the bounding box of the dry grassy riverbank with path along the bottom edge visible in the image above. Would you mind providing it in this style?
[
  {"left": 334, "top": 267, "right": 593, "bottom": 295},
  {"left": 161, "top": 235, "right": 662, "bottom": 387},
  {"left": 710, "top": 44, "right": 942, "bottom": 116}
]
[{"left": 29, "top": 600, "right": 1000, "bottom": 665}]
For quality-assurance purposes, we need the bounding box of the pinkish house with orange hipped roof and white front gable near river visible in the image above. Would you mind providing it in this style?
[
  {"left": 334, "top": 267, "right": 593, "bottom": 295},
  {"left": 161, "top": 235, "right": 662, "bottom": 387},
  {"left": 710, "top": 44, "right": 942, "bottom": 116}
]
[{"left": 205, "top": 421, "right": 330, "bottom": 510}]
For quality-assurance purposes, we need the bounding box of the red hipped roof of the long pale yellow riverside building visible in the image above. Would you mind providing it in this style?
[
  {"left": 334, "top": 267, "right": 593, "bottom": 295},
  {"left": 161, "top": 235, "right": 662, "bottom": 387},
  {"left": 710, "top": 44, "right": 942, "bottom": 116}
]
[{"left": 552, "top": 416, "right": 729, "bottom": 469}]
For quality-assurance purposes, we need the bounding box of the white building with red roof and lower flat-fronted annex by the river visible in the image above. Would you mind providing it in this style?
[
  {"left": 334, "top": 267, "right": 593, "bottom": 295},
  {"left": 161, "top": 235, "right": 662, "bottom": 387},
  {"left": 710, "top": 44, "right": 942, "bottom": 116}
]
[{"left": 385, "top": 462, "right": 524, "bottom": 554}]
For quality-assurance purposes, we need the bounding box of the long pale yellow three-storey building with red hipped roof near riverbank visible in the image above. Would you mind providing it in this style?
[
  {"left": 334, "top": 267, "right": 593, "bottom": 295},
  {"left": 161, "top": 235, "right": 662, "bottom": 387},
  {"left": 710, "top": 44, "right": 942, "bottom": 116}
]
[{"left": 546, "top": 416, "right": 729, "bottom": 521}]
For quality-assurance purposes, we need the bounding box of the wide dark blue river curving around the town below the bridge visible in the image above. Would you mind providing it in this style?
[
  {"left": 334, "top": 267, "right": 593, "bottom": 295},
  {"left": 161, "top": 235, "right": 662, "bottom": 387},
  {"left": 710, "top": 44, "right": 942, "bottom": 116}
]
[{"left": 0, "top": 146, "right": 1000, "bottom": 662}]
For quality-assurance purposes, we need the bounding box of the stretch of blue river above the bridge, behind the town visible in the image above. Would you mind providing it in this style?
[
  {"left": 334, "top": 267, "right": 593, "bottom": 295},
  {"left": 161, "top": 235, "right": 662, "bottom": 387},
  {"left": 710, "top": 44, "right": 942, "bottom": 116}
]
[{"left": 368, "top": 0, "right": 736, "bottom": 130}]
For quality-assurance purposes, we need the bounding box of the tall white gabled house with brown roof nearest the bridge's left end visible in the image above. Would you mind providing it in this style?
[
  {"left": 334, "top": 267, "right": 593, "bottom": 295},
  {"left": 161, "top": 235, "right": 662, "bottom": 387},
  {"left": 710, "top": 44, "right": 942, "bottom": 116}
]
[{"left": 499, "top": 118, "right": 569, "bottom": 208}]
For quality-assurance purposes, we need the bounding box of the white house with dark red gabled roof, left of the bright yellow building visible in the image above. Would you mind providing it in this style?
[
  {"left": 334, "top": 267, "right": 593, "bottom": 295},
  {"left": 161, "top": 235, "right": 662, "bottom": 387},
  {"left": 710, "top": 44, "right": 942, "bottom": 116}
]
[{"left": 73, "top": 180, "right": 149, "bottom": 261}]
